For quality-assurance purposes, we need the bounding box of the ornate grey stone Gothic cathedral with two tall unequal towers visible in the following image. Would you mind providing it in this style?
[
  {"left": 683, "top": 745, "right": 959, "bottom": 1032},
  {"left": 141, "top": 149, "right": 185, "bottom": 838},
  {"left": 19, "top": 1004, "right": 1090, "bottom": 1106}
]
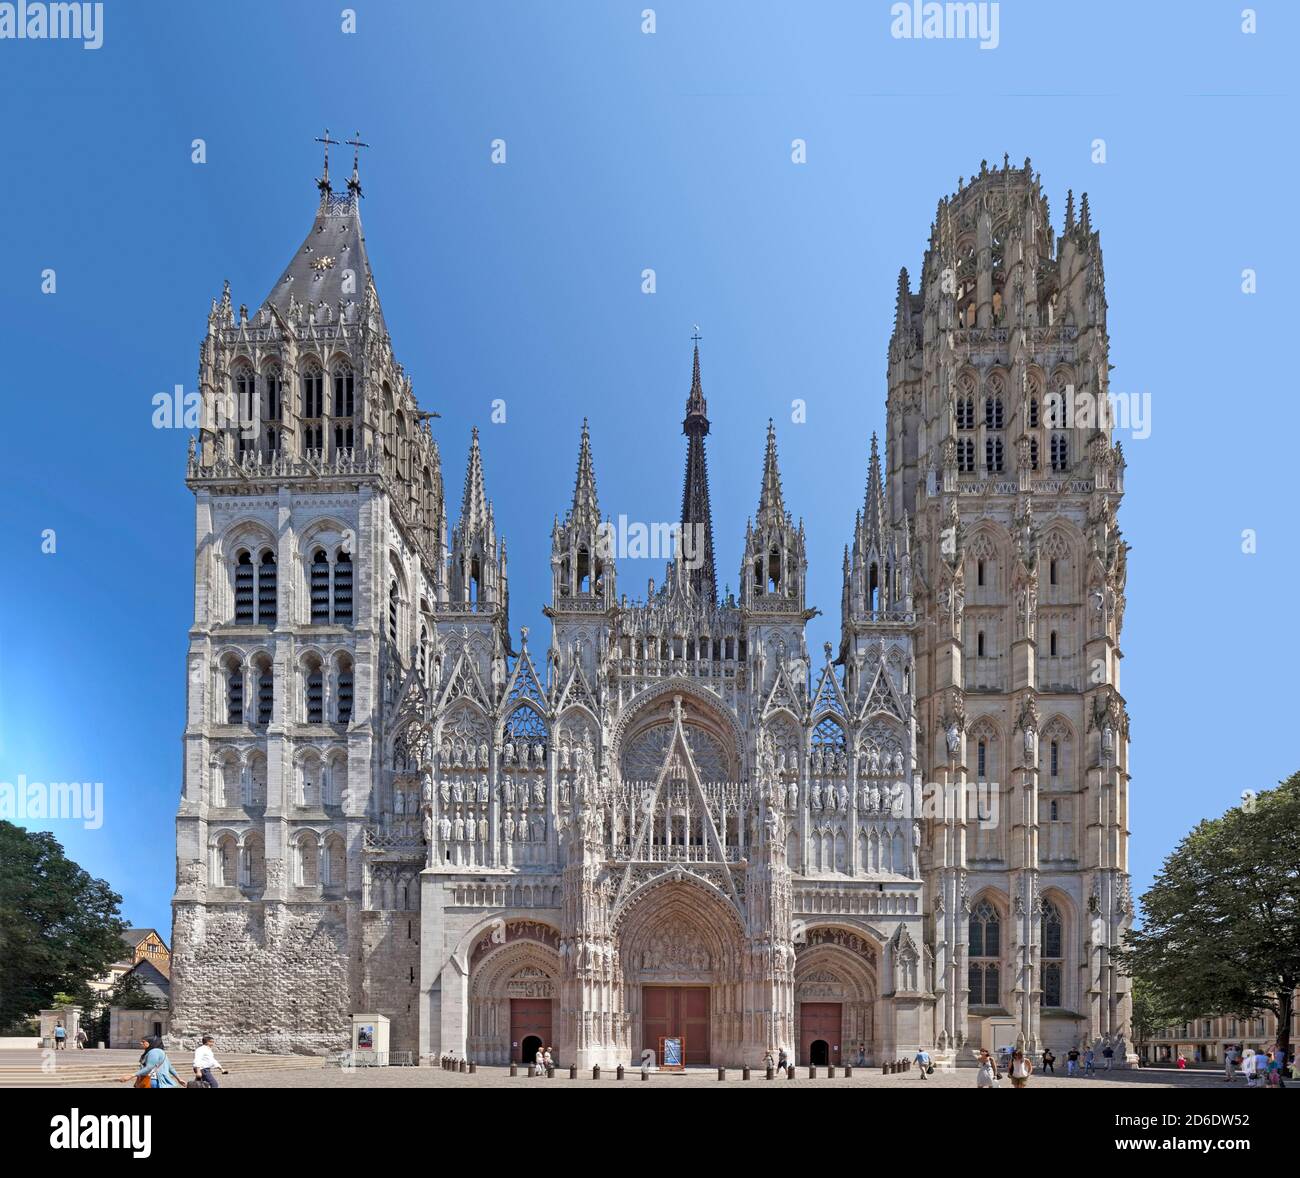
[{"left": 172, "top": 149, "right": 1131, "bottom": 1066}]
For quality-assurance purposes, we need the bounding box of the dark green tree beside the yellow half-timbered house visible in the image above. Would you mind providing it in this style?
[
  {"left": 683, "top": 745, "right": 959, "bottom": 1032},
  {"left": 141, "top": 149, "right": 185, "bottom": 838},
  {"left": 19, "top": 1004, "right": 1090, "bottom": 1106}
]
[{"left": 0, "top": 822, "right": 126, "bottom": 1026}]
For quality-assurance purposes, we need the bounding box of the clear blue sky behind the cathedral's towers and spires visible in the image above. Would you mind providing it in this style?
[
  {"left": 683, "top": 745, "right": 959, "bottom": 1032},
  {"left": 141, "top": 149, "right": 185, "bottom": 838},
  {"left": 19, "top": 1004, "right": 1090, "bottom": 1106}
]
[{"left": 0, "top": 0, "right": 1300, "bottom": 930}]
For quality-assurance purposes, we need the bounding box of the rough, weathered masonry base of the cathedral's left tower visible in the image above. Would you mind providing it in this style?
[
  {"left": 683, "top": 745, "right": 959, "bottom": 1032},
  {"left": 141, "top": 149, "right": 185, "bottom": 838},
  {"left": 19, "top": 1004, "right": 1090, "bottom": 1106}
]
[{"left": 172, "top": 902, "right": 358, "bottom": 1054}]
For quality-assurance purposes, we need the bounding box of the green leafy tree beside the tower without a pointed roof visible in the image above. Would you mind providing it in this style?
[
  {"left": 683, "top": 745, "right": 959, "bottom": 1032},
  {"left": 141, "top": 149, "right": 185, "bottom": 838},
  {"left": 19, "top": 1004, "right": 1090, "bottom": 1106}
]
[{"left": 1122, "top": 774, "right": 1300, "bottom": 1051}]
